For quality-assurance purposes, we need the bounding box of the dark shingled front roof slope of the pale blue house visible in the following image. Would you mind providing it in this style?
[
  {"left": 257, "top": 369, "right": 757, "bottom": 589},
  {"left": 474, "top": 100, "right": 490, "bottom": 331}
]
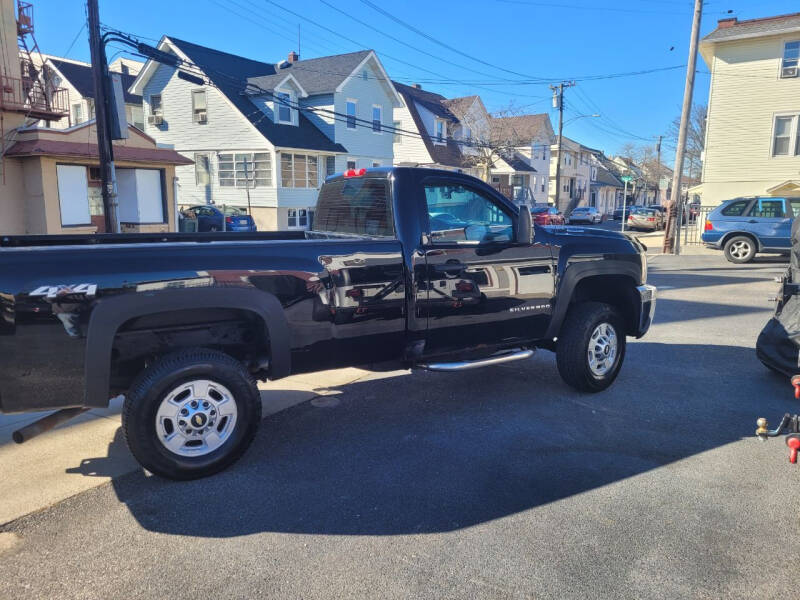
[{"left": 167, "top": 37, "right": 347, "bottom": 152}]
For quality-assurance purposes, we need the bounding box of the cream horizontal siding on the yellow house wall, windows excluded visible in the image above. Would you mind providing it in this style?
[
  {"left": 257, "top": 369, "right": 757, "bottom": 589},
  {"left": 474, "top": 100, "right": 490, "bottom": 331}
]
[{"left": 702, "top": 36, "right": 800, "bottom": 204}]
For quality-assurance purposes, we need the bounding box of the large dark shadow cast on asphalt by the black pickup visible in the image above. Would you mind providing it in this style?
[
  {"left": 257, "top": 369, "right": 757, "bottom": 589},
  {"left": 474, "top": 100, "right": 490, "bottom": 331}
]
[{"left": 101, "top": 342, "right": 794, "bottom": 537}]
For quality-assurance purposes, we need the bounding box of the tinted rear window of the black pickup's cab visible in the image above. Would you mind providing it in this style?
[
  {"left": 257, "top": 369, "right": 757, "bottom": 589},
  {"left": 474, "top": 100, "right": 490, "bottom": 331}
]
[{"left": 314, "top": 177, "right": 394, "bottom": 237}]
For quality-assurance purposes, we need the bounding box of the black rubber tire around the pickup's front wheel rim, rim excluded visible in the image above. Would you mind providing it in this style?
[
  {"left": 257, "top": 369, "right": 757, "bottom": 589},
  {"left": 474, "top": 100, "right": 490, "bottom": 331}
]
[{"left": 556, "top": 302, "right": 626, "bottom": 393}]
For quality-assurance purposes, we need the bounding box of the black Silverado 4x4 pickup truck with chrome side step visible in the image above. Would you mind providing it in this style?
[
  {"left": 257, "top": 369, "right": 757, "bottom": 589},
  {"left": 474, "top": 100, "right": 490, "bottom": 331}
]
[{"left": 0, "top": 167, "right": 655, "bottom": 479}]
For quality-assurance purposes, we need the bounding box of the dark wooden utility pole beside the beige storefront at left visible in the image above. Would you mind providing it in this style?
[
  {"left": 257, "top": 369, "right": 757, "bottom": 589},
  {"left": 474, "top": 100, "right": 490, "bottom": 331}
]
[{"left": 87, "top": 0, "right": 119, "bottom": 233}]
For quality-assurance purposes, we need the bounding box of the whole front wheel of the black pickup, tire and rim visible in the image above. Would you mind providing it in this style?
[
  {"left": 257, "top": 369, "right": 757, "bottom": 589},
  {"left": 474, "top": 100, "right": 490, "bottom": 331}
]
[{"left": 556, "top": 302, "right": 626, "bottom": 392}]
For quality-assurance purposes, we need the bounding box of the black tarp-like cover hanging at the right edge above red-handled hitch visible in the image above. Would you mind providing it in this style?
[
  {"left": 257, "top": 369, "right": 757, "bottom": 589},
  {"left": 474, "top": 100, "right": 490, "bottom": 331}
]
[{"left": 756, "top": 218, "right": 800, "bottom": 376}]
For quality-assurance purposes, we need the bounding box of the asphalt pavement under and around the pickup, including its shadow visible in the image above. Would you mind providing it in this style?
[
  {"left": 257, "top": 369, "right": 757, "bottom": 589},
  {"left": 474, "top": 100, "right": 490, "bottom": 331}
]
[{"left": 0, "top": 253, "right": 800, "bottom": 599}]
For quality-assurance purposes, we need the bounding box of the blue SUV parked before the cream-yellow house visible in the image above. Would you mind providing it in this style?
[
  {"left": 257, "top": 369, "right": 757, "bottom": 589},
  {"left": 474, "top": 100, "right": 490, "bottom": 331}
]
[{"left": 701, "top": 196, "right": 800, "bottom": 263}]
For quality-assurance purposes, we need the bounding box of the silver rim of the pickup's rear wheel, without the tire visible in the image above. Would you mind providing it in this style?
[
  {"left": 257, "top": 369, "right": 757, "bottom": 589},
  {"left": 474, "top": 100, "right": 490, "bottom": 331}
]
[{"left": 155, "top": 379, "right": 238, "bottom": 456}]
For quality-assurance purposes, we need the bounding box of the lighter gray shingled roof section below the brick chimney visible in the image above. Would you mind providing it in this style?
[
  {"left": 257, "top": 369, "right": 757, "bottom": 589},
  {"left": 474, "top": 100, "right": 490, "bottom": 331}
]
[{"left": 248, "top": 50, "right": 372, "bottom": 96}]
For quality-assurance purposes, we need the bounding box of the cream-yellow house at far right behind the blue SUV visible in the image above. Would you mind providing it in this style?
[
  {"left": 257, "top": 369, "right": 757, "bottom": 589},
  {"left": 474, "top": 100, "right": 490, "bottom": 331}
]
[{"left": 689, "top": 13, "right": 800, "bottom": 205}]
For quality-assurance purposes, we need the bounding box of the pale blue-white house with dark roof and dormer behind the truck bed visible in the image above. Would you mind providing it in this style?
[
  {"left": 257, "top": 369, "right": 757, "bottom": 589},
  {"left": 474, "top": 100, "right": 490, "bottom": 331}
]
[{"left": 130, "top": 36, "right": 402, "bottom": 230}]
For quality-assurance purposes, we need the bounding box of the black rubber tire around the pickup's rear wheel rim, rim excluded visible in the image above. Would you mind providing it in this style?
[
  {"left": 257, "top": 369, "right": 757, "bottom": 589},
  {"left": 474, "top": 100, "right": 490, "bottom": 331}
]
[{"left": 122, "top": 348, "right": 261, "bottom": 480}]
